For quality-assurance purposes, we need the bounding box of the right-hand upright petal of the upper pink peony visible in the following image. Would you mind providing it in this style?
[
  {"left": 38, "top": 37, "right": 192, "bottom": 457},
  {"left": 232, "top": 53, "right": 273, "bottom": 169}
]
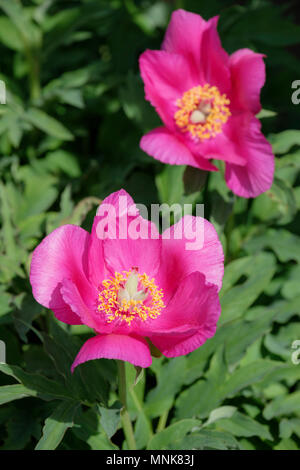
[{"left": 229, "top": 49, "right": 266, "bottom": 114}]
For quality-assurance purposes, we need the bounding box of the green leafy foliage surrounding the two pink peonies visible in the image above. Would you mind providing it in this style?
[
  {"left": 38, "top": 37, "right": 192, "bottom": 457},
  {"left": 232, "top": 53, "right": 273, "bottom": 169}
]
[{"left": 0, "top": 0, "right": 300, "bottom": 449}]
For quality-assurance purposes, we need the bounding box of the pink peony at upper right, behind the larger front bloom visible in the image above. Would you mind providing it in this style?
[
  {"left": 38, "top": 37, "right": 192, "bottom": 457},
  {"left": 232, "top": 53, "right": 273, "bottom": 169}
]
[{"left": 140, "top": 10, "right": 274, "bottom": 197}]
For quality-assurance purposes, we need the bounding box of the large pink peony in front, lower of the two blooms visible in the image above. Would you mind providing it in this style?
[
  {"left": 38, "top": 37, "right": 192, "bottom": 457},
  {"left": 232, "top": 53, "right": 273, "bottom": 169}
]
[{"left": 30, "top": 190, "right": 224, "bottom": 370}]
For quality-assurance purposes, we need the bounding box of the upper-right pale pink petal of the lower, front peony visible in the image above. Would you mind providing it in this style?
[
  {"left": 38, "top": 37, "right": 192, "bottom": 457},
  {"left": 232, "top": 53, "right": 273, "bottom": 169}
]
[{"left": 157, "top": 215, "right": 224, "bottom": 301}]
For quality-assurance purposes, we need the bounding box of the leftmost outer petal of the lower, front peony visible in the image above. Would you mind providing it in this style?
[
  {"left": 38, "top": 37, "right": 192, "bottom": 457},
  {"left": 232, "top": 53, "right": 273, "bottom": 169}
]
[{"left": 30, "top": 225, "right": 93, "bottom": 324}]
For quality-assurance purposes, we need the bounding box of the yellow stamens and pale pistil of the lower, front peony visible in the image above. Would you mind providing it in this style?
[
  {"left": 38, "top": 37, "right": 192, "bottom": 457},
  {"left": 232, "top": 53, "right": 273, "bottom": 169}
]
[{"left": 98, "top": 268, "right": 165, "bottom": 326}]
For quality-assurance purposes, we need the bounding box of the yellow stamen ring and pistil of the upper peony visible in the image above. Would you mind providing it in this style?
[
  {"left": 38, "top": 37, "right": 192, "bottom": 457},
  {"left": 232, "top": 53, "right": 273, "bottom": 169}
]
[{"left": 174, "top": 83, "right": 231, "bottom": 140}]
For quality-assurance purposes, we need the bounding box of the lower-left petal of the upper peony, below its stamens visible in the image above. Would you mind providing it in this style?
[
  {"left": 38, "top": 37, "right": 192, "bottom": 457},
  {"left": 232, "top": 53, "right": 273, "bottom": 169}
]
[{"left": 140, "top": 127, "right": 217, "bottom": 171}]
